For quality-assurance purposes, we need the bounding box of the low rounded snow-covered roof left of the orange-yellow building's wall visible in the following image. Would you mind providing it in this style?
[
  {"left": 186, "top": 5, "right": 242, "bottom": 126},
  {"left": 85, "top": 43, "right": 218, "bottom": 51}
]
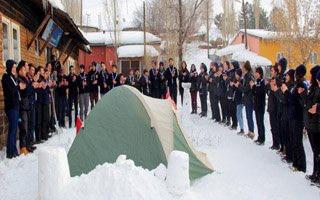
[{"left": 231, "top": 50, "right": 272, "bottom": 66}]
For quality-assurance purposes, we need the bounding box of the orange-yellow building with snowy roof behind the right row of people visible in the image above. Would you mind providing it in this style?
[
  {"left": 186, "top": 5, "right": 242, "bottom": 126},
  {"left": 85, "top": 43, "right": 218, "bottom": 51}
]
[{"left": 231, "top": 29, "right": 320, "bottom": 76}]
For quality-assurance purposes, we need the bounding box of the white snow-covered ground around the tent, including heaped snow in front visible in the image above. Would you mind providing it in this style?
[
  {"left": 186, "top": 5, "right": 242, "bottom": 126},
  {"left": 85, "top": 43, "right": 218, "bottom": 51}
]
[{"left": 0, "top": 44, "right": 320, "bottom": 200}]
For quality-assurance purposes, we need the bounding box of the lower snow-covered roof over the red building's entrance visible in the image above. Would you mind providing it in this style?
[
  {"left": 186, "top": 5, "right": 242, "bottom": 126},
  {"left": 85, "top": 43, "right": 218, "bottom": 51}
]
[{"left": 117, "top": 45, "right": 159, "bottom": 58}]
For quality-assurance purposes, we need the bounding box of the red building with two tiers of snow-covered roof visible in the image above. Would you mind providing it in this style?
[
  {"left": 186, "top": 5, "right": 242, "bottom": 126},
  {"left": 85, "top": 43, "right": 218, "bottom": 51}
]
[{"left": 79, "top": 31, "right": 161, "bottom": 74}]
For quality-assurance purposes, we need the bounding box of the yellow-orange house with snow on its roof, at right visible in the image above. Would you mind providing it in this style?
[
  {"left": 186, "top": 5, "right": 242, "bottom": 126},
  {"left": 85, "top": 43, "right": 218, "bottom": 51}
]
[{"left": 232, "top": 29, "right": 320, "bottom": 78}]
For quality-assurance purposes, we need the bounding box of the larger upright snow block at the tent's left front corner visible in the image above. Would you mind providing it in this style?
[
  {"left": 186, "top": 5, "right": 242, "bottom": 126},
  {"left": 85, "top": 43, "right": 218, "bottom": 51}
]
[{"left": 38, "top": 146, "right": 70, "bottom": 200}]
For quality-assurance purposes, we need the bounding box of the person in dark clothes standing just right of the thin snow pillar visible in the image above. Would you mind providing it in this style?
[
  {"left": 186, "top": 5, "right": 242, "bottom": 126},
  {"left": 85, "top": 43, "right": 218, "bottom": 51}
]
[{"left": 190, "top": 64, "right": 198, "bottom": 114}]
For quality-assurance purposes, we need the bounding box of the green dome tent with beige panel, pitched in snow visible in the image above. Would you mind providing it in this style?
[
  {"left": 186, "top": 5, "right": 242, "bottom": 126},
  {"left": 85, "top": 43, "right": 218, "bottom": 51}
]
[{"left": 68, "top": 86, "right": 213, "bottom": 180}]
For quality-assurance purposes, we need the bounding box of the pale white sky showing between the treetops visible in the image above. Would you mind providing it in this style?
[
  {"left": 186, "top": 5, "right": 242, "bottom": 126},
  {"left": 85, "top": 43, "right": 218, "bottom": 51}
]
[{"left": 83, "top": 0, "right": 273, "bottom": 29}]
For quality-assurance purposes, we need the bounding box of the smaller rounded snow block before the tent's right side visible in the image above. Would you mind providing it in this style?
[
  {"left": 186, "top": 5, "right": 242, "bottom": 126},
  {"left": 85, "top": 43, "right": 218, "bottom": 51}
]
[{"left": 166, "top": 151, "right": 190, "bottom": 195}]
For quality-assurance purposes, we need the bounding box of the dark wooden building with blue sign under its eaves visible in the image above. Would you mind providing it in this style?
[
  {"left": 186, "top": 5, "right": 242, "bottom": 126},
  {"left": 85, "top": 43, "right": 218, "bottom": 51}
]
[{"left": 0, "top": 0, "right": 90, "bottom": 147}]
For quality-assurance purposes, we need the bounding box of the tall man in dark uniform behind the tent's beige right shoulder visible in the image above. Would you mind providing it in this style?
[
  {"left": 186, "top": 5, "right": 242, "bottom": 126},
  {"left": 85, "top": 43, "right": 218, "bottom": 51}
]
[{"left": 165, "top": 58, "right": 178, "bottom": 104}]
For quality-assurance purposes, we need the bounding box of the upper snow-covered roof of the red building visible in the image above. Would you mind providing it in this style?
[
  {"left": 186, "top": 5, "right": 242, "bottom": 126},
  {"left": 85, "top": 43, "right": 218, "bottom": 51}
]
[{"left": 84, "top": 31, "right": 161, "bottom": 45}]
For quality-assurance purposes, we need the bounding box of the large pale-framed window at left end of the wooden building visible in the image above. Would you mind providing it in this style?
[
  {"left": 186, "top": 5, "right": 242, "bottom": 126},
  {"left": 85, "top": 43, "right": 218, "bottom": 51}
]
[{"left": 2, "top": 17, "right": 21, "bottom": 63}]
